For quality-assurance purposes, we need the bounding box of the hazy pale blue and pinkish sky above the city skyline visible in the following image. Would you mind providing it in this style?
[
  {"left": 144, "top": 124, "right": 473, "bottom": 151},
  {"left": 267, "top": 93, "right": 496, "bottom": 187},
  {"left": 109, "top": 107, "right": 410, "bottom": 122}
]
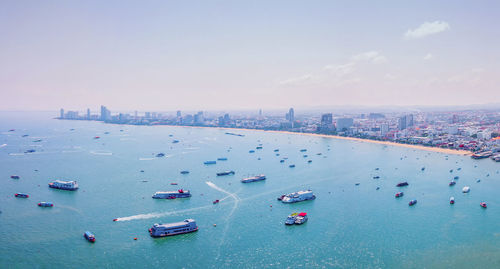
[{"left": 0, "top": 0, "right": 500, "bottom": 111}]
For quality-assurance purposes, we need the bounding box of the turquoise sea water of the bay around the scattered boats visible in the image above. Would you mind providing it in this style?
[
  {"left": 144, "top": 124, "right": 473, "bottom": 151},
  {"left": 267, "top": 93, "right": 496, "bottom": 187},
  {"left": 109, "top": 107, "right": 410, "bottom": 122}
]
[{"left": 0, "top": 112, "right": 500, "bottom": 268}]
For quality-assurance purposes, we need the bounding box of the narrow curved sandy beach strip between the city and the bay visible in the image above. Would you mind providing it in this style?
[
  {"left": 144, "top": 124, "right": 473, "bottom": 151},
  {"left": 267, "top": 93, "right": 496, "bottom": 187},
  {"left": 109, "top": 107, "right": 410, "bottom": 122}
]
[{"left": 154, "top": 125, "right": 472, "bottom": 156}]
